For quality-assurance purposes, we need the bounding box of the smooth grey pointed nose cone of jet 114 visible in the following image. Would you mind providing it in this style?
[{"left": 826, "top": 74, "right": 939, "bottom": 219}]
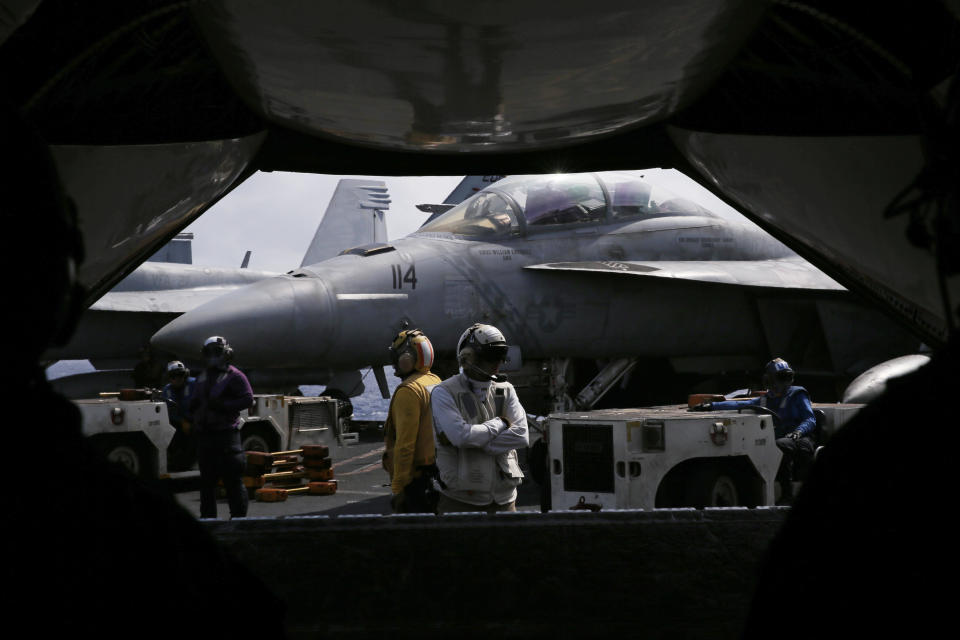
[{"left": 150, "top": 276, "right": 334, "bottom": 368}]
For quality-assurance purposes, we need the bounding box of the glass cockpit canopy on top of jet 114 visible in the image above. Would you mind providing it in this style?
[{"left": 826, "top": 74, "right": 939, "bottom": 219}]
[{"left": 420, "top": 171, "right": 716, "bottom": 237}]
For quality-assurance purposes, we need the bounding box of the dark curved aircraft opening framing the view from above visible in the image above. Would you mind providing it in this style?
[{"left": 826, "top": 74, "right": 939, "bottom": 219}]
[{"left": 0, "top": 0, "right": 960, "bottom": 345}]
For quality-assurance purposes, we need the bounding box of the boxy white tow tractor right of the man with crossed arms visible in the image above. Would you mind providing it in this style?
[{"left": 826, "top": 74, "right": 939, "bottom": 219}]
[{"left": 546, "top": 399, "right": 863, "bottom": 511}]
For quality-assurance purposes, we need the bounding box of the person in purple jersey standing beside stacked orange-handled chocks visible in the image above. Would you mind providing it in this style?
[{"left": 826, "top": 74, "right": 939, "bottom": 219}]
[{"left": 190, "top": 336, "right": 253, "bottom": 518}]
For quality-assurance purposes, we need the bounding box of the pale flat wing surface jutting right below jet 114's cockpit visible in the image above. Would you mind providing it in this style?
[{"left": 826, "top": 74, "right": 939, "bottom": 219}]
[{"left": 524, "top": 257, "right": 845, "bottom": 291}]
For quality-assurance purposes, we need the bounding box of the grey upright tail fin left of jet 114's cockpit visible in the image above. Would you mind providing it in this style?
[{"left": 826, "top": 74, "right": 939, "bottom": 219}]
[{"left": 300, "top": 178, "right": 390, "bottom": 267}]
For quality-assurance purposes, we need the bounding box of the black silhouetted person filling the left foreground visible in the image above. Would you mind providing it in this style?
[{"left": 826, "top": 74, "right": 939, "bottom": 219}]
[{"left": 0, "top": 105, "right": 283, "bottom": 638}]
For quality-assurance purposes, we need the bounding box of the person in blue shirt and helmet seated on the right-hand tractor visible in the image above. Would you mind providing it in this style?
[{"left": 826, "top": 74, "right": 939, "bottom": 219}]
[{"left": 696, "top": 358, "right": 817, "bottom": 504}]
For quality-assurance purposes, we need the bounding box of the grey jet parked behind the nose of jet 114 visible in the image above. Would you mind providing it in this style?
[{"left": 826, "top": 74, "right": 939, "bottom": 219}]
[{"left": 45, "top": 178, "right": 390, "bottom": 397}]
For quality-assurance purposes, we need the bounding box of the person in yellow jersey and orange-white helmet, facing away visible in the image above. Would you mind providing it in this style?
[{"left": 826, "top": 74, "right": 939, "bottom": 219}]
[{"left": 383, "top": 329, "right": 440, "bottom": 513}]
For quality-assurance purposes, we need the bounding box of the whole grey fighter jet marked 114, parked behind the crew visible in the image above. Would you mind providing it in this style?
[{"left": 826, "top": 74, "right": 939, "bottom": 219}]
[{"left": 152, "top": 170, "right": 917, "bottom": 411}]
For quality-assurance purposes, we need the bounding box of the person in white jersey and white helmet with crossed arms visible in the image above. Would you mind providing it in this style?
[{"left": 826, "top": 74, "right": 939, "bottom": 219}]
[{"left": 431, "top": 324, "right": 529, "bottom": 513}]
